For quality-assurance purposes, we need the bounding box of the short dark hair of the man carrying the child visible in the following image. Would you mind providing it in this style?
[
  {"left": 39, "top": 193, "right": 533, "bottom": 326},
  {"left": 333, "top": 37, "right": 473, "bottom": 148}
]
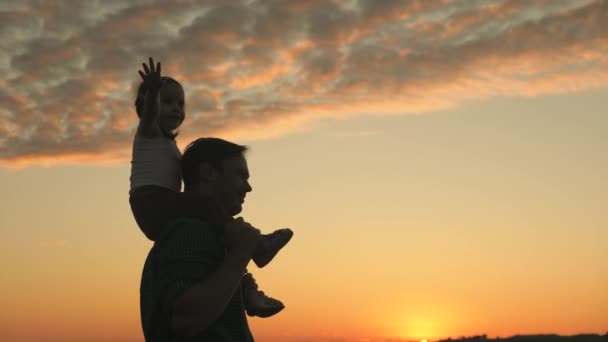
[{"left": 181, "top": 138, "right": 248, "bottom": 189}]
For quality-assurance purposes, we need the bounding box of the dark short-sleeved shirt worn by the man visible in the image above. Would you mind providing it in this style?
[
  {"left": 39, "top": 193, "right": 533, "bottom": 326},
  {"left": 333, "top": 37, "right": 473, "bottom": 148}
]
[{"left": 140, "top": 219, "right": 253, "bottom": 342}]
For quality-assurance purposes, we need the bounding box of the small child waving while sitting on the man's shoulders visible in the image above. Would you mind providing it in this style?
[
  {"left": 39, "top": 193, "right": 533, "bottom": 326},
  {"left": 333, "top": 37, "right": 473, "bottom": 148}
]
[{"left": 129, "top": 58, "right": 293, "bottom": 317}]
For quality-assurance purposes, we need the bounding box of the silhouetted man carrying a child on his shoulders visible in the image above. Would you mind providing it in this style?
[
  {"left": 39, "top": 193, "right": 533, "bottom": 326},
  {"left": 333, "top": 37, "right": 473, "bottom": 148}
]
[{"left": 140, "top": 138, "right": 261, "bottom": 342}]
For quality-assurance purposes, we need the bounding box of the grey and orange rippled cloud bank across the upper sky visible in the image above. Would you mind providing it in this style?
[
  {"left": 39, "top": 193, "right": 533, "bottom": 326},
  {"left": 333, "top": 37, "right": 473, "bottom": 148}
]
[{"left": 0, "top": 0, "right": 608, "bottom": 167}]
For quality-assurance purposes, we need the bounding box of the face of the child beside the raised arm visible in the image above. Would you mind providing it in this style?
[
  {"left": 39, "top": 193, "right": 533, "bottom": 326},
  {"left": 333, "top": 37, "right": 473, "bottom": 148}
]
[{"left": 158, "top": 82, "right": 186, "bottom": 132}]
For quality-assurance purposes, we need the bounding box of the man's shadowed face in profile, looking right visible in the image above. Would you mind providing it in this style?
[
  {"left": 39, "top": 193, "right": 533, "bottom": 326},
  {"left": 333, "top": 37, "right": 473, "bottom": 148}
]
[{"left": 215, "top": 154, "right": 252, "bottom": 216}]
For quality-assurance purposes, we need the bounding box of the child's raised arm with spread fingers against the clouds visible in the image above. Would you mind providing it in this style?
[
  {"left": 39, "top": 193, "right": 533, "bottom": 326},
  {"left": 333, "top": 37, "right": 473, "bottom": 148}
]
[{"left": 136, "top": 57, "right": 163, "bottom": 138}]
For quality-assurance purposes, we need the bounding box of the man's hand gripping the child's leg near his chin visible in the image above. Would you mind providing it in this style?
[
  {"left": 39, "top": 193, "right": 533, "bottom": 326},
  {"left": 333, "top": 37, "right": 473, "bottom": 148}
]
[{"left": 224, "top": 217, "right": 262, "bottom": 262}]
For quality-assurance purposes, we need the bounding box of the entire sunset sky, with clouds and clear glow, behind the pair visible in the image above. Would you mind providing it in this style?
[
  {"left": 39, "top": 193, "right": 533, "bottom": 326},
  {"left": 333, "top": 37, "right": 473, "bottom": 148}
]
[{"left": 0, "top": 0, "right": 608, "bottom": 342}]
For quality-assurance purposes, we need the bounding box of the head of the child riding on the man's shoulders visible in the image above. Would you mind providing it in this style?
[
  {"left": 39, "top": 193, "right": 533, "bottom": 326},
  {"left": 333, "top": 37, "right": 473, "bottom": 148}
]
[{"left": 135, "top": 76, "right": 186, "bottom": 139}]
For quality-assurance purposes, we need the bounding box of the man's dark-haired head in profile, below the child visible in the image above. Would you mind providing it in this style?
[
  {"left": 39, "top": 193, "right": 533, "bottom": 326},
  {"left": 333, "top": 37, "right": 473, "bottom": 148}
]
[{"left": 181, "top": 138, "right": 252, "bottom": 216}]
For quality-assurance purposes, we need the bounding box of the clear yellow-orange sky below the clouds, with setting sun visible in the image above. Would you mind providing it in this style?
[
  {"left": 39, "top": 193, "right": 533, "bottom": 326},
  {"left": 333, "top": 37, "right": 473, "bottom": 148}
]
[{"left": 0, "top": 92, "right": 608, "bottom": 341}]
